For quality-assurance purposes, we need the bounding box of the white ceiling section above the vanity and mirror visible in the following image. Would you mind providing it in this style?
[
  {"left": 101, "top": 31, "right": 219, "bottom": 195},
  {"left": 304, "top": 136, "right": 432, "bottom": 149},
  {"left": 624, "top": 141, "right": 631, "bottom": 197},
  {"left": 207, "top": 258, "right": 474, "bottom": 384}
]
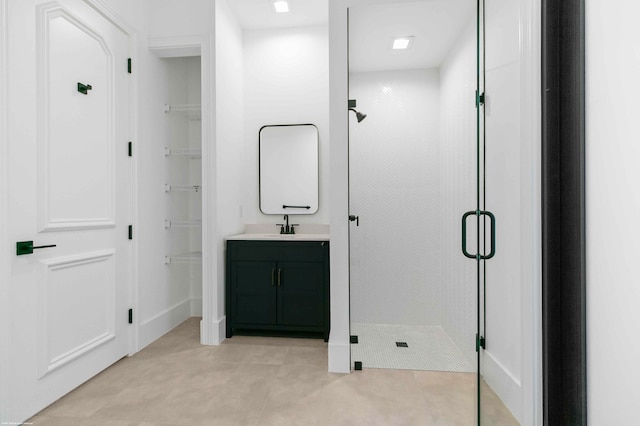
[{"left": 228, "top": 0, "right": 329, "bottom": 30}]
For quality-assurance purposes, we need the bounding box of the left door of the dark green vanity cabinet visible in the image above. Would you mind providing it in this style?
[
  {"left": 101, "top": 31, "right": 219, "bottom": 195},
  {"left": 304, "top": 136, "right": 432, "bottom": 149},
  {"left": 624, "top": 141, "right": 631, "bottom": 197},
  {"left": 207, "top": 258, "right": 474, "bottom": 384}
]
[{"left": 231, "top": 262, "right": 277, "bottom": 325}]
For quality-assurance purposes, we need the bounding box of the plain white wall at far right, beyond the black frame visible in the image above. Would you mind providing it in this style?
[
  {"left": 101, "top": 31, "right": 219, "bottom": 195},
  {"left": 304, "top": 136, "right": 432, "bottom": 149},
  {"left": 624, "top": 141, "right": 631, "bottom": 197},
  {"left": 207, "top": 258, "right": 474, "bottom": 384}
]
[{"left": 586, "top": 0, "right": 640, "bottom": 425}]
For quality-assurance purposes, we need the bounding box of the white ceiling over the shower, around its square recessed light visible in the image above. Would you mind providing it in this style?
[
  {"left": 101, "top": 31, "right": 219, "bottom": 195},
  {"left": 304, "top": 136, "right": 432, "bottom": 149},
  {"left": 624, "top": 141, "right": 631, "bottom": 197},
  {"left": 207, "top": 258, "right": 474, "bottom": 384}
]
[{"left": 349, "top": 0, "right": 476, "bottom": 72}]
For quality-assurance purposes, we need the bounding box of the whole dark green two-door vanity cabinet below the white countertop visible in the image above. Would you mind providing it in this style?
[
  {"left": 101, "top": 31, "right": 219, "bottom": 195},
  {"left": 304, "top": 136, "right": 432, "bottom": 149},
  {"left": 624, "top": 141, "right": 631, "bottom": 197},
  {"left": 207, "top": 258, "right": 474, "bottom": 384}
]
[{"left": 225, "top": 240, "right": 329, "bottom": 341}]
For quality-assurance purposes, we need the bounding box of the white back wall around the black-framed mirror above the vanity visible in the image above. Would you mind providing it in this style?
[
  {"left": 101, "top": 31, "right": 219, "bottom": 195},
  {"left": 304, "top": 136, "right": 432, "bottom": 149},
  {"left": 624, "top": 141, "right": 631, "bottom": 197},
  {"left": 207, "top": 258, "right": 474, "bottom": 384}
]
[{"left": 238, "top": 26, "right": 329, "bottom": 226}]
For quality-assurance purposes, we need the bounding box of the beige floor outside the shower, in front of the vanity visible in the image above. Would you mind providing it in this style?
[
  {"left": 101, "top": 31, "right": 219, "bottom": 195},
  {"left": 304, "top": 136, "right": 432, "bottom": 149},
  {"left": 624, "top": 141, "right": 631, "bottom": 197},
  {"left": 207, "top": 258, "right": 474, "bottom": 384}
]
[{"left": 29, "top": 318, "right": 517, "bottom": 426}]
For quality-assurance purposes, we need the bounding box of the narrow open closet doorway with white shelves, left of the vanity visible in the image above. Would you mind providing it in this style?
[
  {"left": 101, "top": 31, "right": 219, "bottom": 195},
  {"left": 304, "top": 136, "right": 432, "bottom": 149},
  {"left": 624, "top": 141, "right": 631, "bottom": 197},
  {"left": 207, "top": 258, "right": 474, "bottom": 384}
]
[{"left": 142, "top": 38, "right": 210, "bottom": 347}]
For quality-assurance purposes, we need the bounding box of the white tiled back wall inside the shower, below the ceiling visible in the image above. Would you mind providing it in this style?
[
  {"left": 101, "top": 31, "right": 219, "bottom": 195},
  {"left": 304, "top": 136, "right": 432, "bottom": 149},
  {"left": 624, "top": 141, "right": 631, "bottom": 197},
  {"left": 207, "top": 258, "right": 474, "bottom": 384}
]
[{"left": 349, "top": 69, "right": 442, "bottom": 325}]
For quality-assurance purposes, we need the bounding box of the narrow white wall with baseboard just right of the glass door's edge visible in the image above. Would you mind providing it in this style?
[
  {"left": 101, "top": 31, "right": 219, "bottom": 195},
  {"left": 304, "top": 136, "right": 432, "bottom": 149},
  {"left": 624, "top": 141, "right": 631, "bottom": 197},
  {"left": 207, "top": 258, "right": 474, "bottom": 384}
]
[{"left": 483, "top": 0, "right": 533, "bottom": 419}]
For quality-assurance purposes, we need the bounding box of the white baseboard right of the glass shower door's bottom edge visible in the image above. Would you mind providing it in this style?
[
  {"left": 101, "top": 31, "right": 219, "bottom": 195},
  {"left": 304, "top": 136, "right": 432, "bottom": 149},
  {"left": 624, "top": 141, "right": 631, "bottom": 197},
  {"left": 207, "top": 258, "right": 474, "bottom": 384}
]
[{"left": 482, "top": 351, "right": 522, "bottom": 423}]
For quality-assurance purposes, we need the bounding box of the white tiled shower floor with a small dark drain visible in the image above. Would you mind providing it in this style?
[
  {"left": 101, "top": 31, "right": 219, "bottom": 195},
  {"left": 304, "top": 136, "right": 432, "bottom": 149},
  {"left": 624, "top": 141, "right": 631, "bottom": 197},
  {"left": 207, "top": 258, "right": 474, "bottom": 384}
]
[{"left": 351, "top": 323, "right": 475, "bottom": 373}]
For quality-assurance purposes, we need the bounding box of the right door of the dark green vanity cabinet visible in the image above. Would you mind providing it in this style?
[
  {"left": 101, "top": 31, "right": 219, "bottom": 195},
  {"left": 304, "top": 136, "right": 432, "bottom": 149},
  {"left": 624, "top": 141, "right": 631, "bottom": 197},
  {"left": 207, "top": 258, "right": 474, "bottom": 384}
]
[{"left": 278, "top": 261, "right": 325, "bottom": 327}]
